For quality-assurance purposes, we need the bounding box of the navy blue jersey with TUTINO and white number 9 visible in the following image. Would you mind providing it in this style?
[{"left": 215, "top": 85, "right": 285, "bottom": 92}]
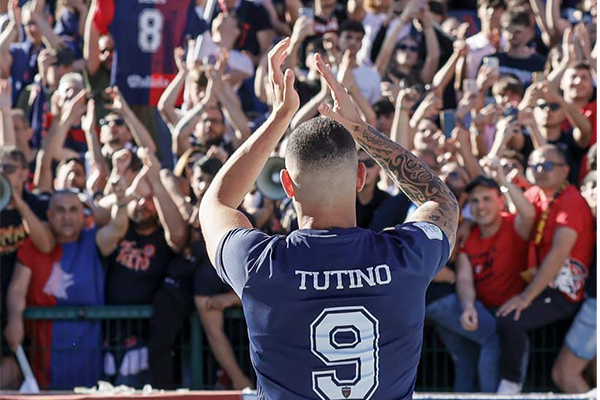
[{"left": 217, "top": 222, "right": 450, "bottom": 400}]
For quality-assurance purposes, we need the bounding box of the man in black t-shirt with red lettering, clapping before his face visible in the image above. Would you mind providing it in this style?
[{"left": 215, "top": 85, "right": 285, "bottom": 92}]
[{"left": 105, "top": 148, "right": 187, "bottom": 386}]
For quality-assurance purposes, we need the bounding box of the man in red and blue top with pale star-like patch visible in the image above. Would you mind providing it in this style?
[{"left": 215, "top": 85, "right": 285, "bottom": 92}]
[{"left": 5, "top": 187, "right": 127, "bottom": 390}]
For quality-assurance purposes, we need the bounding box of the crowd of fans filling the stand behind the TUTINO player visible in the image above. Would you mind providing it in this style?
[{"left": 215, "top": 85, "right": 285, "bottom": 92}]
[{"left": 0, "top": 0, "right": 597, "bottom": 393}]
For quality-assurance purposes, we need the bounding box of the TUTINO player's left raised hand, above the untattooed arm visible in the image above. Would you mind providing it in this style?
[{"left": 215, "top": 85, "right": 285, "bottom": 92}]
[{"left": 268, "top": 38, "right": 300, "bottom": 115}]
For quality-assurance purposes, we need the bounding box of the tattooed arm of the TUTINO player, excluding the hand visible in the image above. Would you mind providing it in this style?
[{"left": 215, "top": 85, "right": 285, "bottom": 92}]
[{"left": 352, "top": 125, "right": 459, "bottom": 248}]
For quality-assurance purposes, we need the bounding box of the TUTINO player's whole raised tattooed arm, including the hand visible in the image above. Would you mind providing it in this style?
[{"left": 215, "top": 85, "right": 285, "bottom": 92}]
[{"left": 316, "top": 55, "right": 459, "bottom": 249}]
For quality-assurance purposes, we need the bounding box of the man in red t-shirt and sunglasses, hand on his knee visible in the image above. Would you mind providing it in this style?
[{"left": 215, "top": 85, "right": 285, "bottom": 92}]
[{"left": 497, "top": 145, "right": 594, "bottom": 394}]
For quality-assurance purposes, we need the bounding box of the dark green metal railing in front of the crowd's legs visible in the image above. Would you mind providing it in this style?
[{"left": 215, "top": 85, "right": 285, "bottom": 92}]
[{"left": 17, "top": 306, "right": 571, "bottom": 392}]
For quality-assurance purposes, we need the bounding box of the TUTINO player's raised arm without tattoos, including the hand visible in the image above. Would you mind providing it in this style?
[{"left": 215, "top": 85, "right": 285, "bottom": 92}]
[{"left": 200, "top": 38, "right": 300, "bottom": 265}]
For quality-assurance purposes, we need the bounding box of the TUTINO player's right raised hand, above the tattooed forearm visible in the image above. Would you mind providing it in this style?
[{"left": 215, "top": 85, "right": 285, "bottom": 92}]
[{"left": 315, "top": 53, "right": 366, "bottom": 135}]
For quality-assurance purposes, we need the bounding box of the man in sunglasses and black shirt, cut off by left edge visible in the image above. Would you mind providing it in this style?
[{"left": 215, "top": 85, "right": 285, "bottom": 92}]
[{"left": 0, "top": 146, "right": 54, "bottom": 389}]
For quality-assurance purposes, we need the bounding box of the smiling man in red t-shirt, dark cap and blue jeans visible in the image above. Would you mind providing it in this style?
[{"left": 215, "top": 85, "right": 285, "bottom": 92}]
[{"left": 432, "top": 160, "right": 535, "bottom": 392}]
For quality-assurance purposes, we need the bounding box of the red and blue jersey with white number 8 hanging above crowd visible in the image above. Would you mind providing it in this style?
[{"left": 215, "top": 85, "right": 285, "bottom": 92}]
[{"left": 94, "top": 0, "right": 208, "bottom": 106}]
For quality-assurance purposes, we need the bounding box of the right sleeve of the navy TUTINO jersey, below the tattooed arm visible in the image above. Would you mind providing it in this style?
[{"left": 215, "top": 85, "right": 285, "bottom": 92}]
[{"left": 384, "top": 221, "right": 450, "bottom": 280}]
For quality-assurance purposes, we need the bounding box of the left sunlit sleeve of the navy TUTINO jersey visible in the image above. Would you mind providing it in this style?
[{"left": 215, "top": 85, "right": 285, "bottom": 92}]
[{"left": 215, "top": 228, "right": 273, "bottom": 299}]
